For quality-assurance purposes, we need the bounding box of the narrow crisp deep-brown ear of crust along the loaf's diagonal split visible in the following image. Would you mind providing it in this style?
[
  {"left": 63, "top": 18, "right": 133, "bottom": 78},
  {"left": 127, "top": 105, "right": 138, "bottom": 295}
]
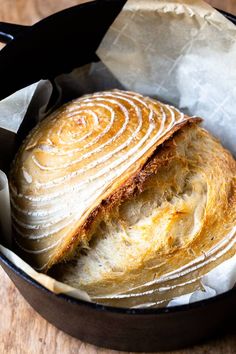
[{"left": 50, "top": 118, "right": 202, "bottom": 271}]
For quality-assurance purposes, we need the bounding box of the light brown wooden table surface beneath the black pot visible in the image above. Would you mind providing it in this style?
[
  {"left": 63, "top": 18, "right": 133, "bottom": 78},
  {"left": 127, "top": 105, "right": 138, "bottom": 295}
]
[{"left": 0, "top": 0, "right": 236, "bottom": 354}]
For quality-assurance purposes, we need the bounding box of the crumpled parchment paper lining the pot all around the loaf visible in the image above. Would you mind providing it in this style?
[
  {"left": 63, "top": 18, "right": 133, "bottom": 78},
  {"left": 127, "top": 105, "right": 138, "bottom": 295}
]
[{"left": 0, "top": 0, "right": 236, "bottom": 306}]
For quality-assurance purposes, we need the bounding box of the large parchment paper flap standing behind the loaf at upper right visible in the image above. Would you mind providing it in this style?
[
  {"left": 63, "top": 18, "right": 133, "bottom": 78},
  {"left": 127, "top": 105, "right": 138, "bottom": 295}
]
[{"left": 97, "top": 0, "right": 236, "bottom": 154}]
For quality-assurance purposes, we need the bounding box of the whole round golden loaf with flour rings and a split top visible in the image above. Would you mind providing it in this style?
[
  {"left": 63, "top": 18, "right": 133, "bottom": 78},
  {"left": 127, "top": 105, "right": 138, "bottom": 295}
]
[{"left": 10, "top": 90, "right": 236, "bottom": 306}]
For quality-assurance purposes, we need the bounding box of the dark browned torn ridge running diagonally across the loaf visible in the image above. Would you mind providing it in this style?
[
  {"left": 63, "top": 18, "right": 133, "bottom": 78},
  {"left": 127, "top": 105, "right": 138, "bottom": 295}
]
[{"left": 47, "top": 116, "right": 202, "bottom": 273}]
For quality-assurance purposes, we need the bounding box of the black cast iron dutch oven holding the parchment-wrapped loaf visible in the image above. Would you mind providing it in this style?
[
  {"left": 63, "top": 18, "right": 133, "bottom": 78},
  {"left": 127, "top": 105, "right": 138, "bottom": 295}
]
[{"left": 0, "top": 0, "right": 236, "bottom": 352}]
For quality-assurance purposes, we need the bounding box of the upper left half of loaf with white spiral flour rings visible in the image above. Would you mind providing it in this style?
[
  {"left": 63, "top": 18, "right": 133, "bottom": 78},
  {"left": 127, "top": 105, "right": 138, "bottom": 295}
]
[{"left": 10, "top": 90, "right": 195, "bottom": 270}]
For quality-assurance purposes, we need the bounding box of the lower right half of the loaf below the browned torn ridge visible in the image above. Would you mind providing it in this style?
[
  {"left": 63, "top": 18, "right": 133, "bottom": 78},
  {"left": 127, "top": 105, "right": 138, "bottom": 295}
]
[{"left": 52, "top": 124, "right": 236, "bottom": 307}]
